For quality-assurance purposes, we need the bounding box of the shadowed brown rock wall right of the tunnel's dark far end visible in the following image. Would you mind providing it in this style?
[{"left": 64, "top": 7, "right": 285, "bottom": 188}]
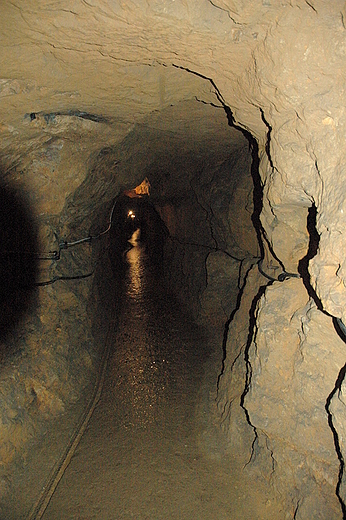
[{"left": 157, "top": 131, "right": 259, "bottom": 331}]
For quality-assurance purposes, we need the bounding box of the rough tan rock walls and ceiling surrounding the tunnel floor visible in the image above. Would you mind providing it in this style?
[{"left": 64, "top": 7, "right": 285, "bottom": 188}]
[{"left": 0, "top": 0, "right": 346, "bottom": 520}]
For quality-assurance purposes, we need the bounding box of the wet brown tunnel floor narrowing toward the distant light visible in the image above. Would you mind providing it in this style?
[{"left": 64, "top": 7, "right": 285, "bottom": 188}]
[{"left": 39, "top": 233, "right": 250, "bottom": 520}]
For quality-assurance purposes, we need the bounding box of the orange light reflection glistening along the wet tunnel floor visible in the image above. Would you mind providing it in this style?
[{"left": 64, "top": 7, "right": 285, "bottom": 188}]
[{"left": 105, "top": 234, "right": 203, "bottom": 429}]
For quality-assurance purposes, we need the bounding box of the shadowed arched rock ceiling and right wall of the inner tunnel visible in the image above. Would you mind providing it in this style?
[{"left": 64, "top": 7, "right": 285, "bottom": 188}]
[{"left": 88, "top": 100, "right": 260, "bottom": 332}]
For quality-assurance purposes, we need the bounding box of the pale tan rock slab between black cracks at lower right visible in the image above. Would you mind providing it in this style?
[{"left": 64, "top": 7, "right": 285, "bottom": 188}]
[{"left": 244, "top": 279, "right": 344, "bottom": 518}]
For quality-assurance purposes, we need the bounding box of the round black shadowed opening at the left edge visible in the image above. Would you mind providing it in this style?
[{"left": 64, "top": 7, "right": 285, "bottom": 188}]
[{"left": 0, "top": 185, "right": 38, "bottom": 346}]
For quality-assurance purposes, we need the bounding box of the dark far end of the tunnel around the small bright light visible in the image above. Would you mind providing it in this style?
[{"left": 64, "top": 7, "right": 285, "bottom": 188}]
[{"left": 109, "top": 195, "right": 169, "bottom": 276}]
